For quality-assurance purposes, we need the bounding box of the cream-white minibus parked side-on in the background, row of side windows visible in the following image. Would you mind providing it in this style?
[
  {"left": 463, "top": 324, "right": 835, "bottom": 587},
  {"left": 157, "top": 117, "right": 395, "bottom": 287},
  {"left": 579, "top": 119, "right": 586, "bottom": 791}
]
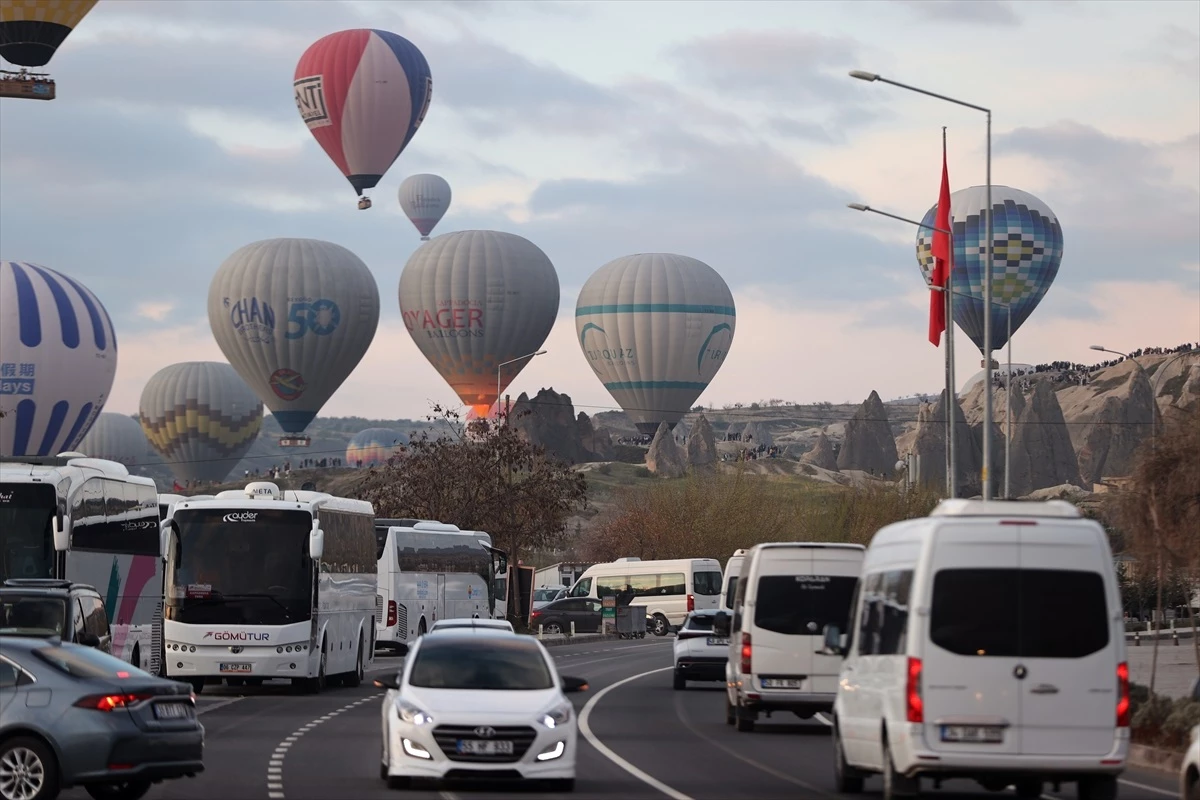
[{"left": 568, "top": 558, "right": 721, "bottom": 636}]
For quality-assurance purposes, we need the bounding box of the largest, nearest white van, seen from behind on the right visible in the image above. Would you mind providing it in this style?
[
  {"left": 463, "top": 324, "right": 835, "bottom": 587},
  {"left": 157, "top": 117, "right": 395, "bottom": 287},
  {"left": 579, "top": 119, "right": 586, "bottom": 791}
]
[{"left": 824, "top": 500, "right": 1129, "bottom": 800}]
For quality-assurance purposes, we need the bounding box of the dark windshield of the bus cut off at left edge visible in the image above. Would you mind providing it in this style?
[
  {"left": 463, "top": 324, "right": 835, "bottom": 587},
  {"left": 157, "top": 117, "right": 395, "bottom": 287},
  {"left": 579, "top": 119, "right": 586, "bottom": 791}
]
[{"left": 0, "top": 483, "right": 58, "bottom": 582}]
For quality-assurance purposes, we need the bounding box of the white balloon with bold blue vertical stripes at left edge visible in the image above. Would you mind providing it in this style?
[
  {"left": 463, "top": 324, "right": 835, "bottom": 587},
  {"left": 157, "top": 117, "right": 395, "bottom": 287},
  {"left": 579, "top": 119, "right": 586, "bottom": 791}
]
[{"left": 0, "top": 260, "right": 116, "bottom": 456}]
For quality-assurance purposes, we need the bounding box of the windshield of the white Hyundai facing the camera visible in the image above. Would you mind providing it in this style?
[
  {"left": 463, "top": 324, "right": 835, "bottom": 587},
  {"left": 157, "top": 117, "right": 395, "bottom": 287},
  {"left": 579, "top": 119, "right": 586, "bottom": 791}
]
[{"left": 408, "top": 636, "right": 554, "bottom": 691}]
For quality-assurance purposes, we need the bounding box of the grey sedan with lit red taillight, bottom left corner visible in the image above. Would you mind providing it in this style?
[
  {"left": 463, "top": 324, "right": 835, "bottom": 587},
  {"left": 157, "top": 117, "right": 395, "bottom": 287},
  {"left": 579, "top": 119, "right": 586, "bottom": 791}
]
[{"left": 0, "top": 637, "right": 204, "bottom": 800}]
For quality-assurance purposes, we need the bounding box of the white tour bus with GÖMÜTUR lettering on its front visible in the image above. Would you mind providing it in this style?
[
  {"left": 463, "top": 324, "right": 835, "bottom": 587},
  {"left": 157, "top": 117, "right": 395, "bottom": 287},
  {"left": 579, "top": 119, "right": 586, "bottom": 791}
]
[{"left": 162, "top": 481, "right": 376, "bottom": 693}]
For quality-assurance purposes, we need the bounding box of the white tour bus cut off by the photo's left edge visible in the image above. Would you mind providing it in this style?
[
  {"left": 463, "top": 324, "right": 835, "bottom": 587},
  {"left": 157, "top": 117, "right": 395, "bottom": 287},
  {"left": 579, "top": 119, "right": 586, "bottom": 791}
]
[{"left": 0, "top": 452, "right": 163, "bottom": 674}]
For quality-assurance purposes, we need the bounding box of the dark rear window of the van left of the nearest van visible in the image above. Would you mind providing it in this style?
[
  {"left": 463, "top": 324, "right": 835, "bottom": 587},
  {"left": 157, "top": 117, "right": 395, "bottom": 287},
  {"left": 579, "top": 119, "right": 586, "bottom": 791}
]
[{"left": 754, "top": 575, "right": 858, "bottom": 636}]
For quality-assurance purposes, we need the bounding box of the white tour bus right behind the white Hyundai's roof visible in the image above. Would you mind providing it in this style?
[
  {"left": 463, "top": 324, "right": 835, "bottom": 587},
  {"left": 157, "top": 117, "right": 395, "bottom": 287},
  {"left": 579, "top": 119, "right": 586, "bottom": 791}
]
[{"left": 376, "top": 519, "right": 508, "bottom": 650}]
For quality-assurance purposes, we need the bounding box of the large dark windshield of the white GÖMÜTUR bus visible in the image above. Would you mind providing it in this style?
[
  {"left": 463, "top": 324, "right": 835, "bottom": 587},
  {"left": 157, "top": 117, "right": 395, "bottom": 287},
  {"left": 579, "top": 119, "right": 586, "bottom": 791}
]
[{"left": 166, "top": 509, "right": 312, "bottom": 625}]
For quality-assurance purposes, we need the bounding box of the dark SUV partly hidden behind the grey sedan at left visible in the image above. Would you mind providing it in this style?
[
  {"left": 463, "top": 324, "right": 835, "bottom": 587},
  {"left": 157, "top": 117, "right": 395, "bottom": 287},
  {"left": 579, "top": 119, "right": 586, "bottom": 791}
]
[{"left": 0, "top": 578, "right": 113, "bottom": 652}]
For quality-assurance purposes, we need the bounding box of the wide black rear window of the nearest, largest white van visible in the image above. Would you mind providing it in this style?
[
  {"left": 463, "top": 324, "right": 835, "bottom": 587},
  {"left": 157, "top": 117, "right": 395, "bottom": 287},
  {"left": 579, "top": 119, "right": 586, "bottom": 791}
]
[{"left": 929, "top": 569, "right": 1109, "bottom": 658}]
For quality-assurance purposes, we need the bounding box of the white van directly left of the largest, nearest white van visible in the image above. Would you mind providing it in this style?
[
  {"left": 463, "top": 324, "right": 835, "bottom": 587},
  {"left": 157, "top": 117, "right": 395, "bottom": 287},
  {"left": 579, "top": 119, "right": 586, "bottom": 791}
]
[{"left": 713, "top": 542, "right": 865, "bottom": 730}]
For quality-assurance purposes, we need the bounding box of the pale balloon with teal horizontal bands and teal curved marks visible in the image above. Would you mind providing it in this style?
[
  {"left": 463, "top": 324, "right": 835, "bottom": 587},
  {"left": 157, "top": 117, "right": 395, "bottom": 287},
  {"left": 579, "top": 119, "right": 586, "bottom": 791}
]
[{"left": 575, "top": 253, "right": 737, "bottom": 433}]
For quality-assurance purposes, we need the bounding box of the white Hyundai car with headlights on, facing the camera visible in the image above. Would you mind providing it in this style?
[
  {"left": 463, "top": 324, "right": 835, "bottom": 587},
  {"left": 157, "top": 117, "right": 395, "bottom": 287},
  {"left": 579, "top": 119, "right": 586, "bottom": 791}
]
[{"left": 374, "top": 627, "right": 588, "bottom": 792}]
